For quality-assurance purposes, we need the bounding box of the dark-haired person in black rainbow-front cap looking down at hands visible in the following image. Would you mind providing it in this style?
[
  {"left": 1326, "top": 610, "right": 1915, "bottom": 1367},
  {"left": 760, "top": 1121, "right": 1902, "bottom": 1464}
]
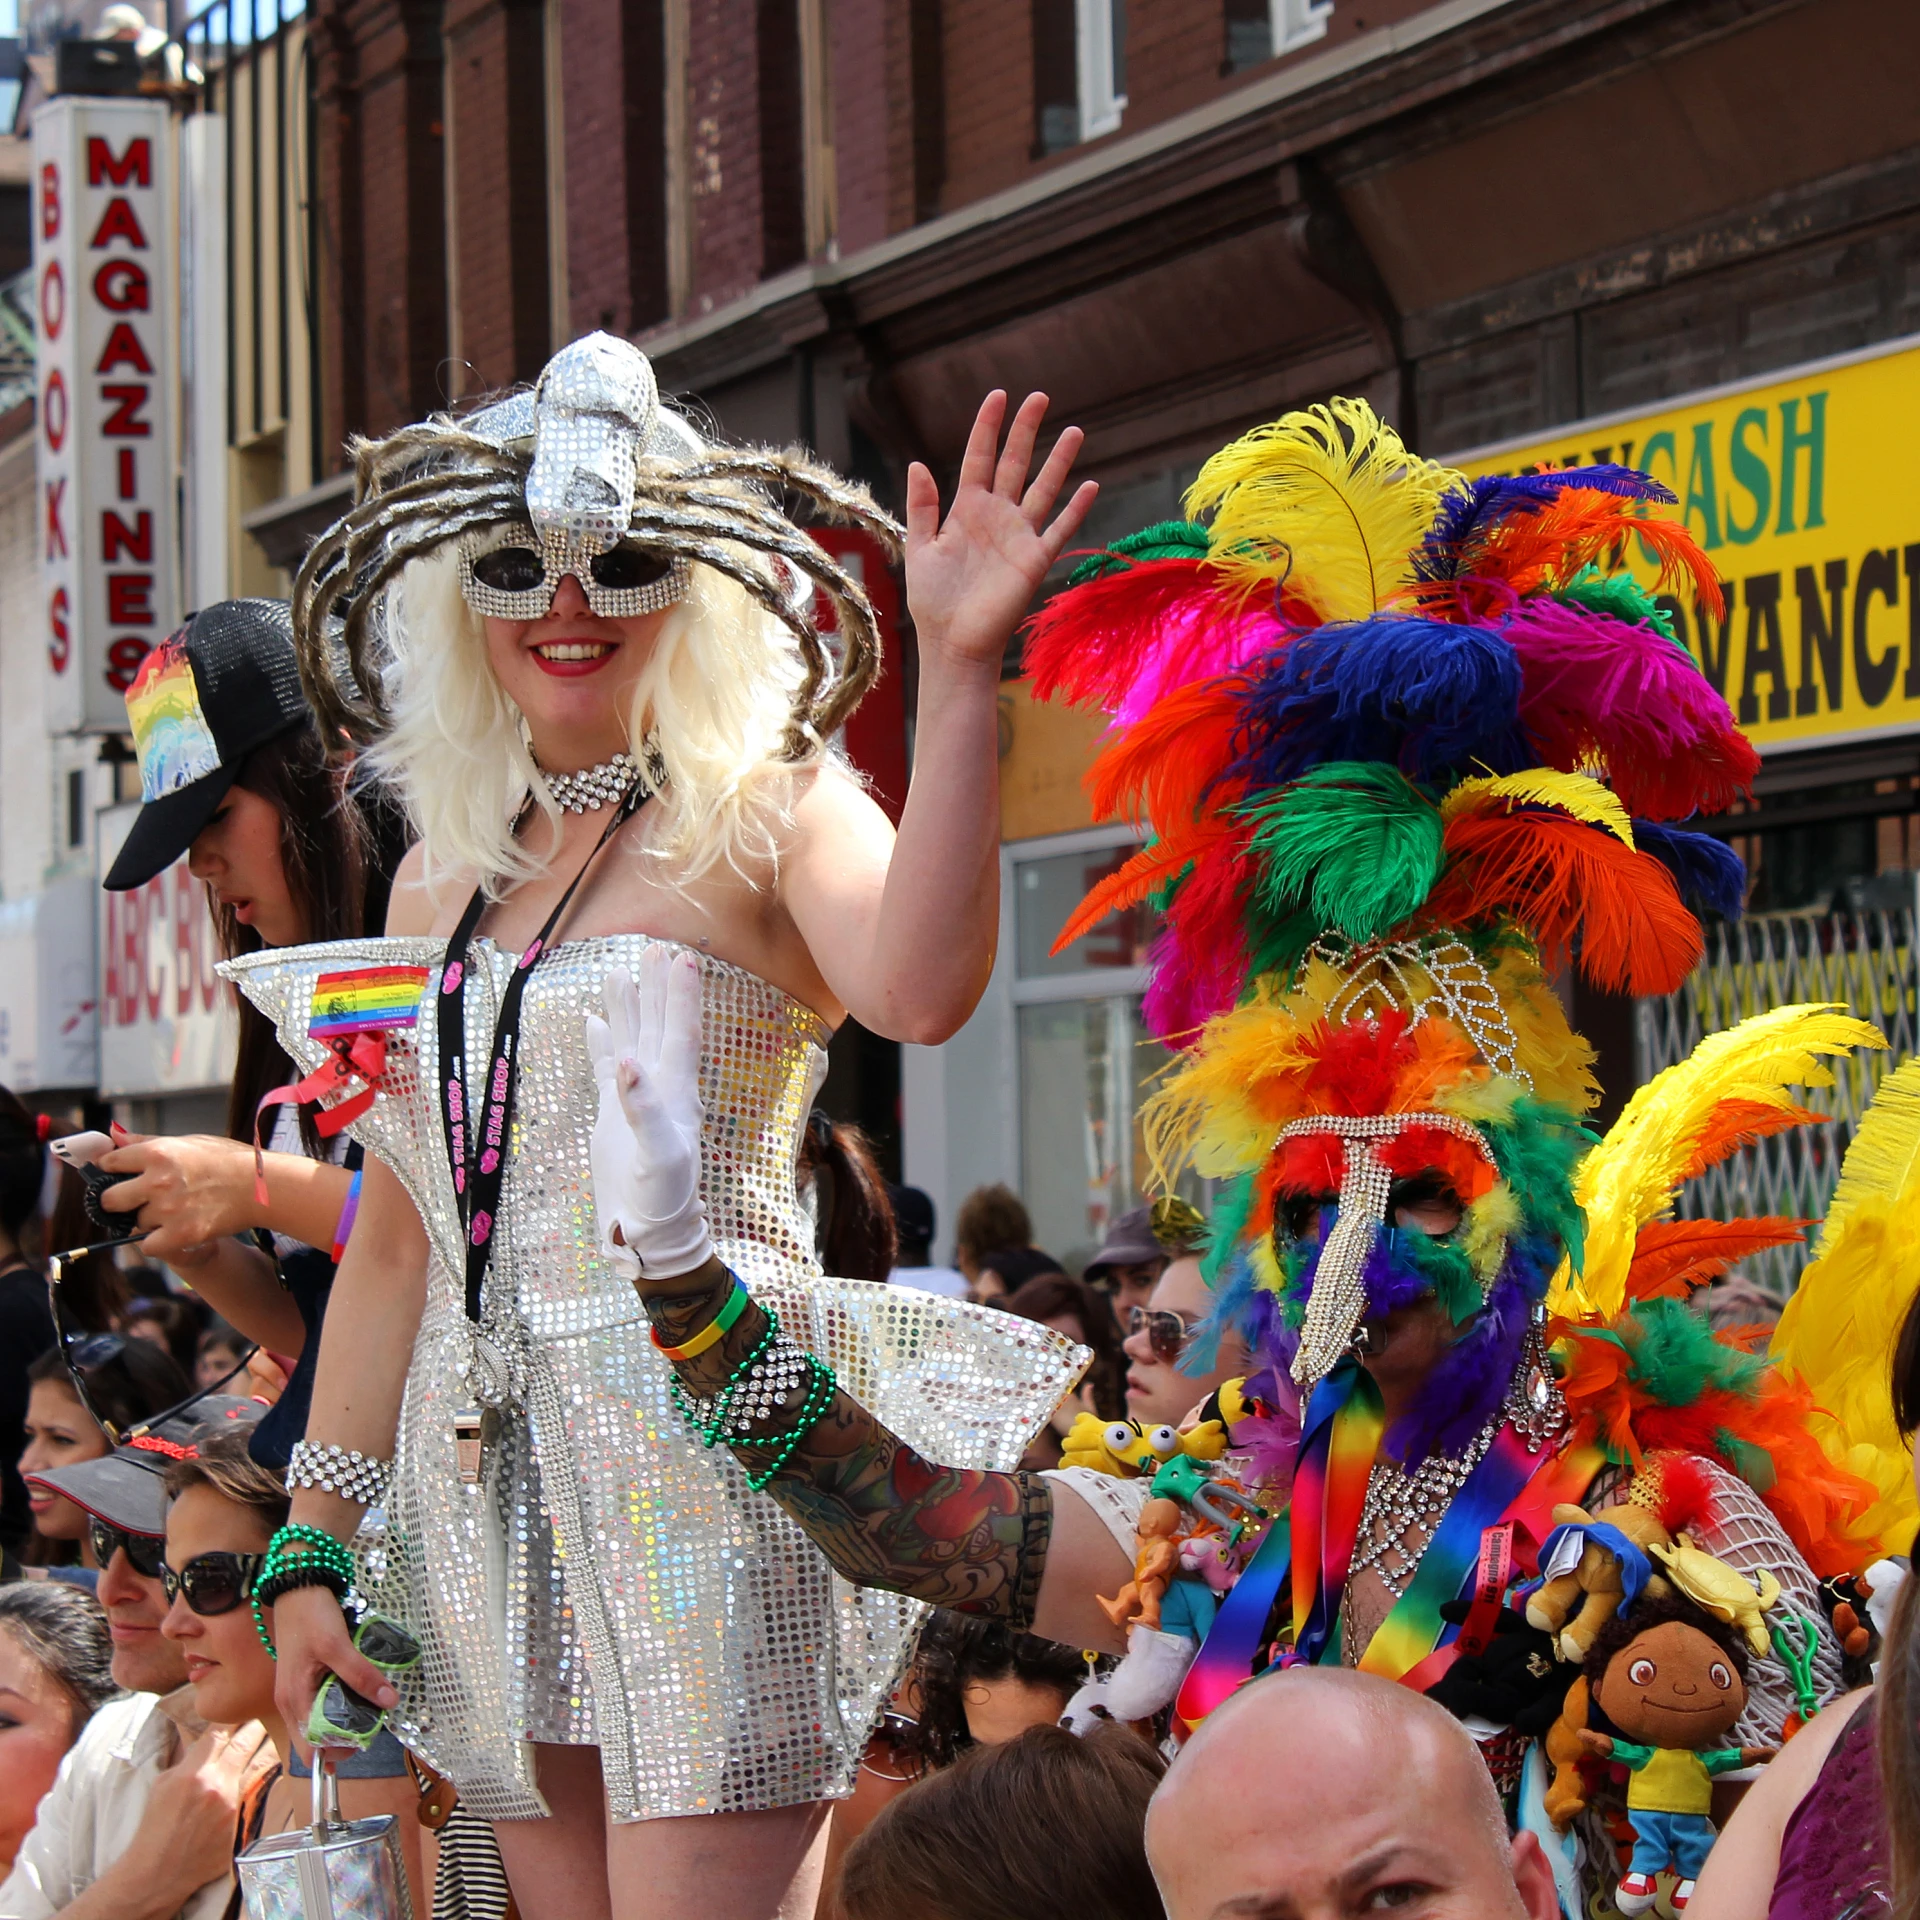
[{"left": 88, "top": 599, "right": 401, "bottom": 1465}]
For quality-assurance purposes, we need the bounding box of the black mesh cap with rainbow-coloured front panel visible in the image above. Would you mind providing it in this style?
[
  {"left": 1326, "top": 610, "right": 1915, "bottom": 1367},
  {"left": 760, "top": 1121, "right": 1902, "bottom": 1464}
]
[{"left": 106, "top": 599, "right": 311, "bottom": 893}]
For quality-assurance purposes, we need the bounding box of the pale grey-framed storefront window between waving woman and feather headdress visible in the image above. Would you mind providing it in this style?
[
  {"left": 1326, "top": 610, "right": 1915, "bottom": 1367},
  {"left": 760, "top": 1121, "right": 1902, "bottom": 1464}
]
[{"left": 1006, "top": 828, "right": 1206, "bottom": 1267}]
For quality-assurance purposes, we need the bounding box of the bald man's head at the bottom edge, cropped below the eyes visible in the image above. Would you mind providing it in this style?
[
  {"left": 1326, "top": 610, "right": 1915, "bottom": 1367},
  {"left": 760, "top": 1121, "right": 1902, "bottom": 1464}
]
[{"left": 1146, "top": 1667, "right": 1559, "bottom": 1920}]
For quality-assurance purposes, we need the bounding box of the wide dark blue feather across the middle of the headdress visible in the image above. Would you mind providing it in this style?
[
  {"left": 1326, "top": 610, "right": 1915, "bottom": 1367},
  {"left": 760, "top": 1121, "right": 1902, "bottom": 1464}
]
[{"left": 1225, "top": 614, "right": 1532, "bottom": 791}]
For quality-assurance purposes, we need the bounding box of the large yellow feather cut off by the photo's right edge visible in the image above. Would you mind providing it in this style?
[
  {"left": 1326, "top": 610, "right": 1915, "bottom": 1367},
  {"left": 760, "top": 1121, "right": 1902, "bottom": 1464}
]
[{"left": 1772, "top": 1060, "right": 1920, "bottom": 1553}]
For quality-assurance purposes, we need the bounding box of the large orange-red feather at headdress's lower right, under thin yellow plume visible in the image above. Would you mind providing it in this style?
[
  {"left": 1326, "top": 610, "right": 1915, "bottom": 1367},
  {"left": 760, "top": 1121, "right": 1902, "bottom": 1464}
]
[{"left": 1423, "top": 810, "right": 1703, "bottom": 996}]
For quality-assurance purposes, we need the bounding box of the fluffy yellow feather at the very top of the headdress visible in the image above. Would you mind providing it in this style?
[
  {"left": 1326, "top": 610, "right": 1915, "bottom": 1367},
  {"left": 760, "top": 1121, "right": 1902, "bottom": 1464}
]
[{"left": 1187, "top": 399, "right": 1467, "bottom": 620}]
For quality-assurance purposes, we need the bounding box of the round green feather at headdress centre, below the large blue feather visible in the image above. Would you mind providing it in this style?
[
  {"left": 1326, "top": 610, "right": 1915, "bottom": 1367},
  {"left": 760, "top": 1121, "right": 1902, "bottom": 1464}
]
[{"left": 1235, "top": 760, "right": 1444, "bottom": 941}]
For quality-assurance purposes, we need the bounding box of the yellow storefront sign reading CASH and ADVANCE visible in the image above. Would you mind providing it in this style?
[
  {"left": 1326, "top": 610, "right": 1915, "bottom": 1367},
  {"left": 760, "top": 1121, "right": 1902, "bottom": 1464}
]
[{"left": 1450, "top": 340, "right": 1920, "bottom": 749}]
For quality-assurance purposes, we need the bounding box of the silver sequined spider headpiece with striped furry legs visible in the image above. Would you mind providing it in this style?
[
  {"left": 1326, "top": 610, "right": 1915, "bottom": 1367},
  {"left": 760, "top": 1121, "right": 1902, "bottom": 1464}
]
[{"left": 294, "top": 334, "right": 900, "bottom": 760}]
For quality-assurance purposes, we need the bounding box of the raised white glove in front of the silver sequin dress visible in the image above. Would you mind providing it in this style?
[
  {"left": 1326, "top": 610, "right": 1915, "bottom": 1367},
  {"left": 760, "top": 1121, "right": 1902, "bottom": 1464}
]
[{"left": 586, "top": 947, "right": 714, "bottom": 1281}]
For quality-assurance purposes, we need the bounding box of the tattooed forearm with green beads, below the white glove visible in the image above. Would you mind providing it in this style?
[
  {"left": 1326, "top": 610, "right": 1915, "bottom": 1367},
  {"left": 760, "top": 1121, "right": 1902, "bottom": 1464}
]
[{"left": 647, "top": 1269, "right": 1052, "bottom": 1626}]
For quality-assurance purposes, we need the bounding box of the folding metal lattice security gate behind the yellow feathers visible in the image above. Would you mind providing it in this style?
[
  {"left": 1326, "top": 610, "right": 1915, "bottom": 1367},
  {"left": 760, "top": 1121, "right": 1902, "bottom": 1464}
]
[{"left": 1634, "top": 876, "right": 1920, "bottom": 1302}]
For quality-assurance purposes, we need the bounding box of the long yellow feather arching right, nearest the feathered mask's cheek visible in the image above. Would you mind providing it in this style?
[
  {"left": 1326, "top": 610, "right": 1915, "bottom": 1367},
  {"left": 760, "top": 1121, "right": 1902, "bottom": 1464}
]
[{"left": 1548, "top": 1002, "right": 1887, "bottom": 1319}]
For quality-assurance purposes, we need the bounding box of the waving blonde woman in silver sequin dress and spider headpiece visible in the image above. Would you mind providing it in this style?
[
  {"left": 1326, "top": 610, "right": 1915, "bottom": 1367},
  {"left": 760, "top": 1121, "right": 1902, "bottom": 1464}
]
[{"left": 243, "top": 336, "right": 1091, "bottom": 1920}]
